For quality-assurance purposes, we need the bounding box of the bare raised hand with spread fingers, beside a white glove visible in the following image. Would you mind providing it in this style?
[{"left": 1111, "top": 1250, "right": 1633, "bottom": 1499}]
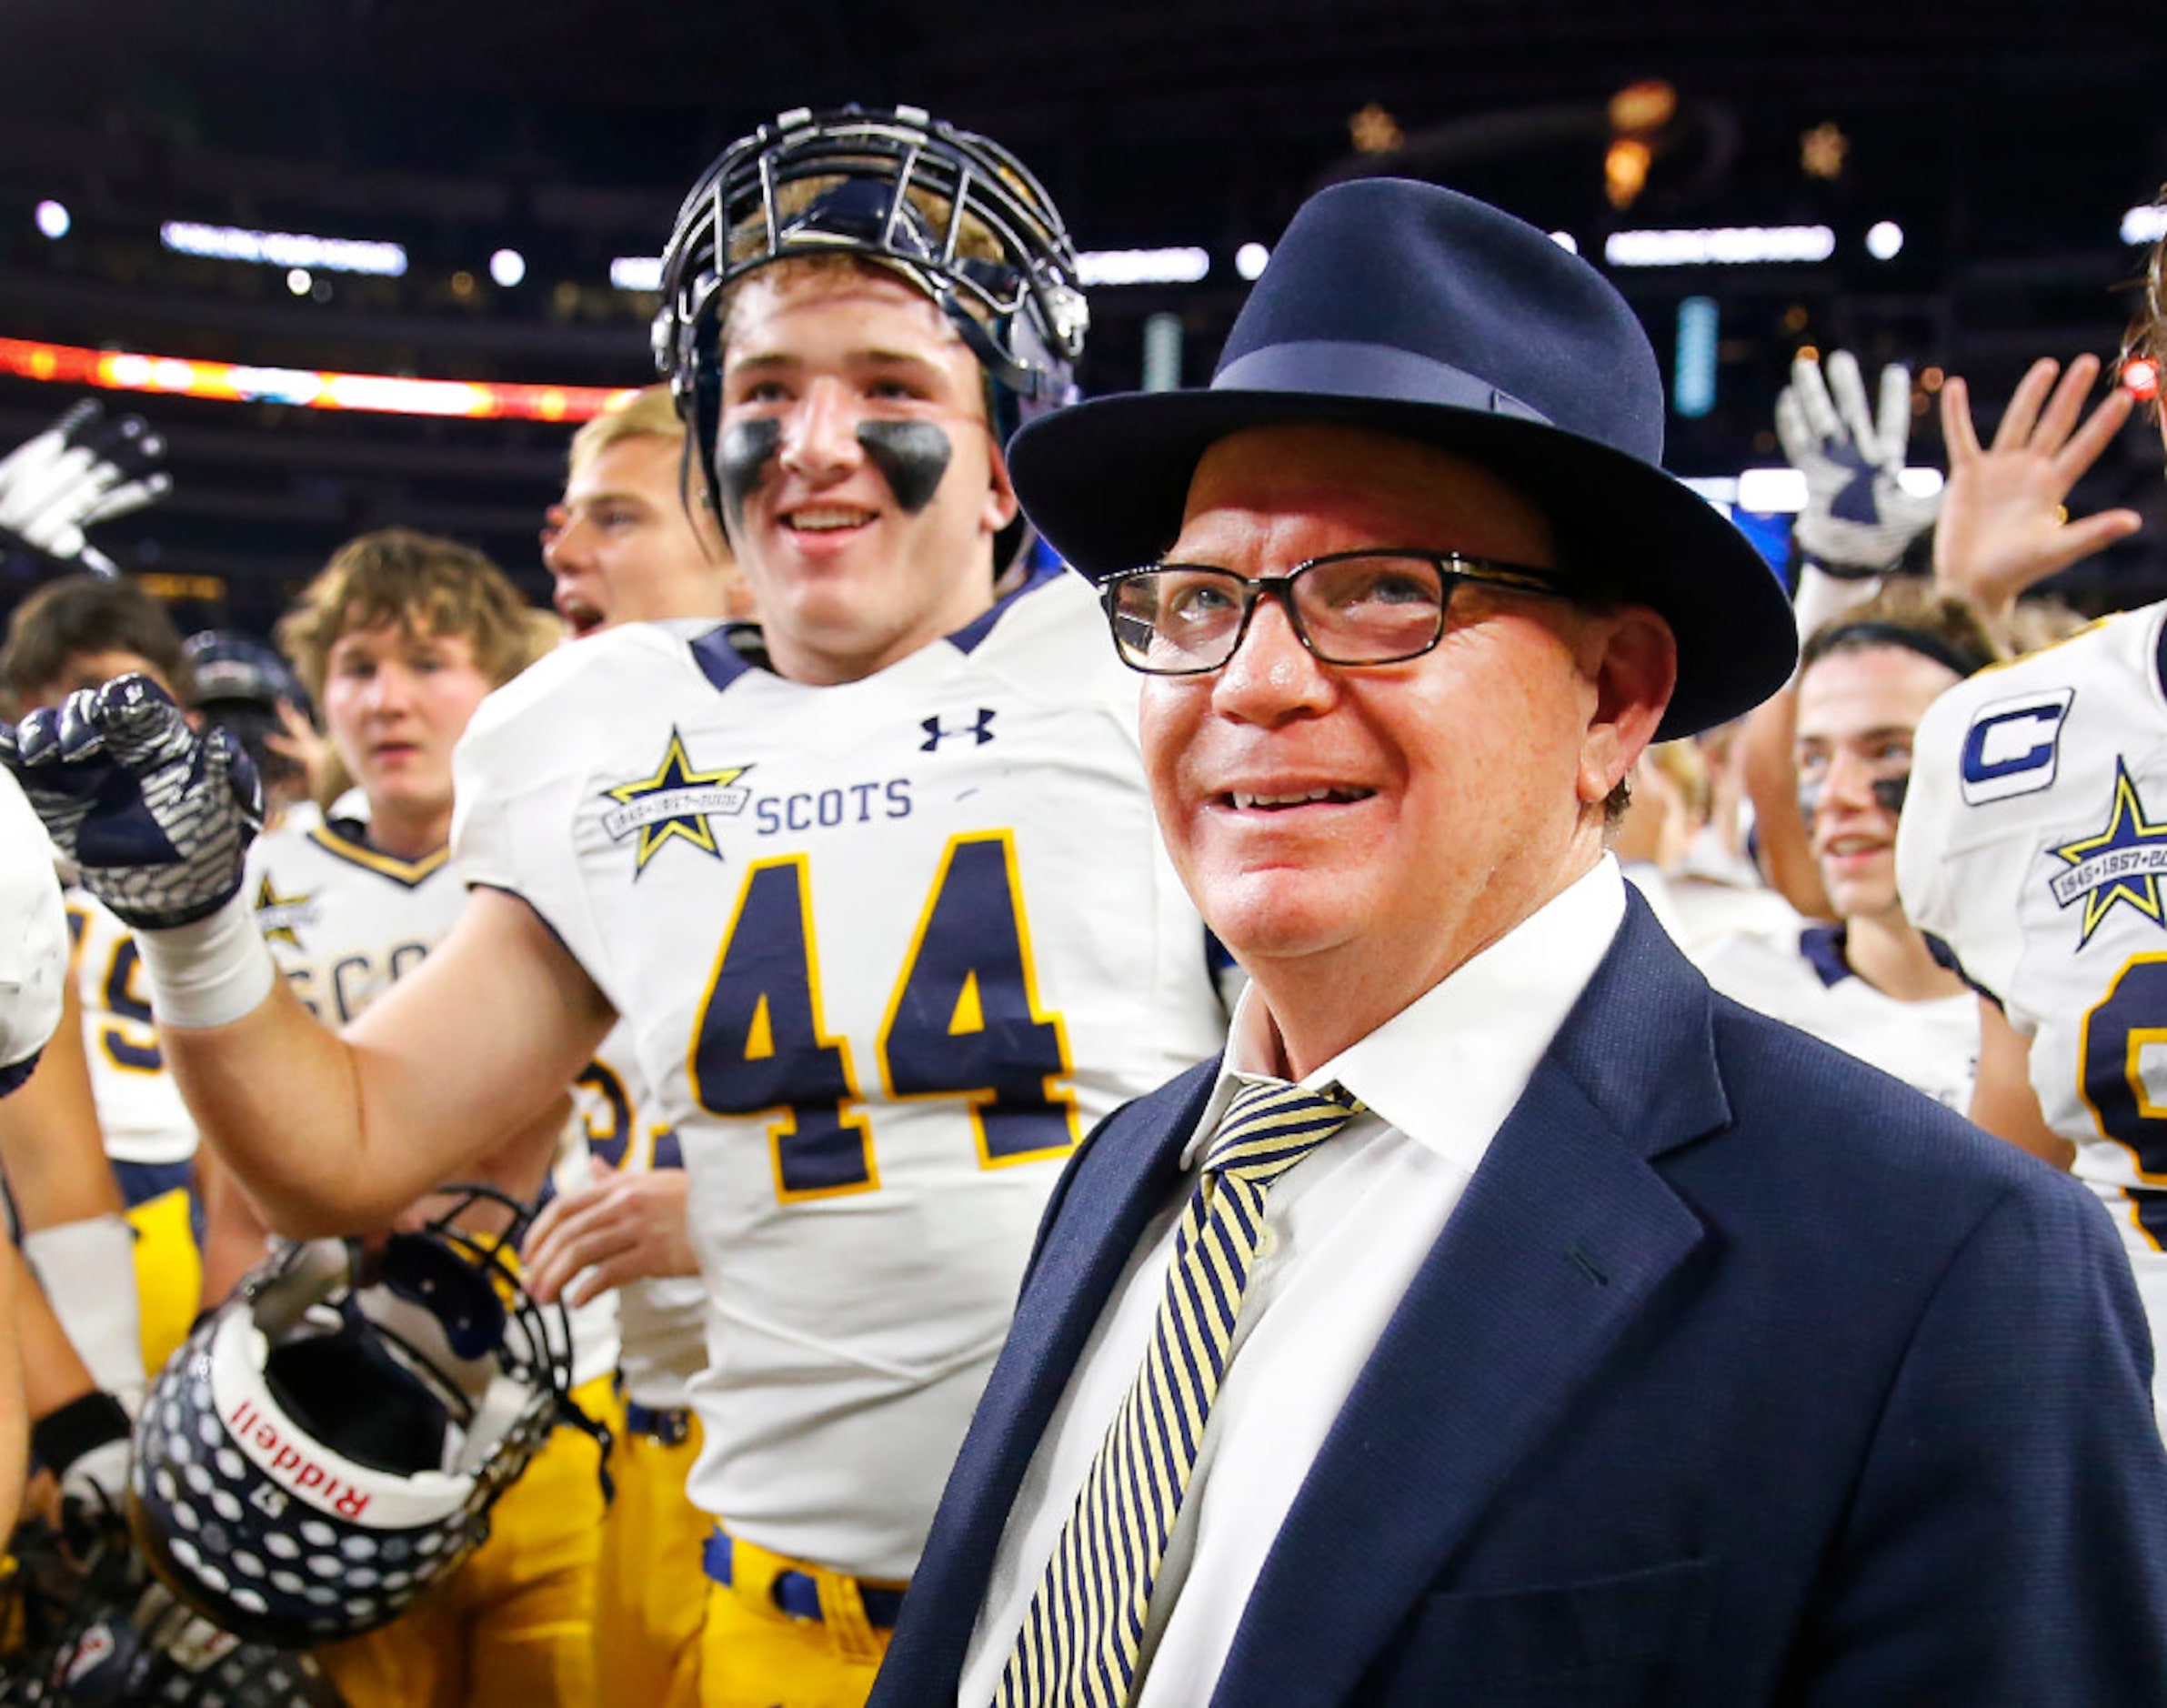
[{"left": 1933, "top": 356, "right": 2143, "bottom": 618}]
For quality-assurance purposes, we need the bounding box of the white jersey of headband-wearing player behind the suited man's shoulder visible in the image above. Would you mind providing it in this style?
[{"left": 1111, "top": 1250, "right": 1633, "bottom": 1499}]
[{"left": 1692, "top": 926, "right": 1979, "bottom": 1114}]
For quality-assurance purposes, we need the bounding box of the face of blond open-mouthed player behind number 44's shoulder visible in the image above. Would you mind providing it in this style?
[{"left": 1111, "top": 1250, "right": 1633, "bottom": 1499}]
[{"left": 542, "top": 434, "right": 726, "bottom": 639}]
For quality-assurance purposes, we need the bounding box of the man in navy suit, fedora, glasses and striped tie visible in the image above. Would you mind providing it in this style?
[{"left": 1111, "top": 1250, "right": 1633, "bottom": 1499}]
[{"left": 876, "top": 180, "right": 2167, "bottom": 1708}]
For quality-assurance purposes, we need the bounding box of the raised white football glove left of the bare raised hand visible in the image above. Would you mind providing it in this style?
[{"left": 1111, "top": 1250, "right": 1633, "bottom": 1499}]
[{"left": 1775, "top": 349, "right": 1941, "bottom": 577}]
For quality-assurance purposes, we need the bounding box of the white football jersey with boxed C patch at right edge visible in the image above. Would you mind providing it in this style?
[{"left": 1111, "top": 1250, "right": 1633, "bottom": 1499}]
[{"left": 1896, "top": 605, "right": 2167, "bottom": 1248}]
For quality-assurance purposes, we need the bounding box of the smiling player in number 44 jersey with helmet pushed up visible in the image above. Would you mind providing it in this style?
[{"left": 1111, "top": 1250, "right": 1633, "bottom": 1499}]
[{"left": 0, "top": 108, "right": 1224, "bottom": 1708}]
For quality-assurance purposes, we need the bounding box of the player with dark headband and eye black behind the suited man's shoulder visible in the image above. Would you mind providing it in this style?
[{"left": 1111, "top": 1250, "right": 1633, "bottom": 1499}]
[{"left": 1695, "top": 583, "right": 1996, "bottom": 1110}]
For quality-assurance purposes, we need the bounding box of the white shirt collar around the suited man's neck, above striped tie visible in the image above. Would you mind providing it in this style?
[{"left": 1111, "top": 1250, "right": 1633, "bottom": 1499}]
[{"left": 1181, "top": 854, "right": 1625, "bottom": 1170}]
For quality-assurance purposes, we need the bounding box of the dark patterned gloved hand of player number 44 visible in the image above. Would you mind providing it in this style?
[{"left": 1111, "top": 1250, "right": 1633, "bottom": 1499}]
[{"left": 0, "top": 674, "right": 262, "bottom": 929}]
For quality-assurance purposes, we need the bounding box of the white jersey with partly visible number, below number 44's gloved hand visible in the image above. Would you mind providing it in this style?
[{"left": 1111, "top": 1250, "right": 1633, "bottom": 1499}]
[{"left": 65, "top": 889, "right": 195, "bottom": 1164}]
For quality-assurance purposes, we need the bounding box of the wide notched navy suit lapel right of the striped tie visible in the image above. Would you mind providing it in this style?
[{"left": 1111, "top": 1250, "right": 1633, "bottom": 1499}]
[{"left": 1218, "top": 898, "right": 1730, "bottom": 1703}]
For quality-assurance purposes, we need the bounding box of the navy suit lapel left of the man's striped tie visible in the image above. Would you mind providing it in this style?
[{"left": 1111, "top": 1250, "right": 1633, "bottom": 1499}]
[{"left": 879, "top": 1060, "right": 1218, "bottom": 1695}]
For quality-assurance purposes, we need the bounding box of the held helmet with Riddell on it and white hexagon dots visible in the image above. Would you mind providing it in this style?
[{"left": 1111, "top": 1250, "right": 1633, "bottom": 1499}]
[{"left": 128, "top": 1186, "right": 600, "bottom": 1643}]
